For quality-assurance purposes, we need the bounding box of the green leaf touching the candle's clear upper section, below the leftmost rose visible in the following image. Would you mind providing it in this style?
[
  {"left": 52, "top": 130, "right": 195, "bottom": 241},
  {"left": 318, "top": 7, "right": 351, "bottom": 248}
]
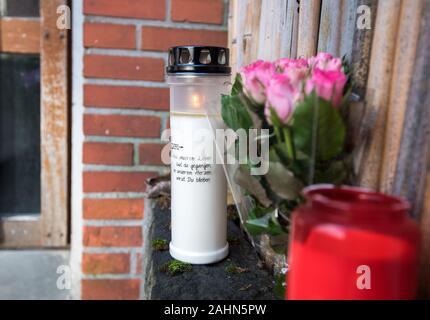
[{"left": 221, "top": 95, "right": 253, "bottom": 131}]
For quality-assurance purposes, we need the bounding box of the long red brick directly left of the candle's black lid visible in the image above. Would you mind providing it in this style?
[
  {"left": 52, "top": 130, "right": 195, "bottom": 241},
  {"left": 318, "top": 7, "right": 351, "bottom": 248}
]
[{"left": 84, "top": 54, "right": 164, "bottom": 81}]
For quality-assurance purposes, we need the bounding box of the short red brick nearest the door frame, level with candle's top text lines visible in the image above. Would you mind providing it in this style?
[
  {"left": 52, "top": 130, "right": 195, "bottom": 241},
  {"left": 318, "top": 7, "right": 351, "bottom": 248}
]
[{"left": 83, "top": 142, "right": 133, "bottom": 166}]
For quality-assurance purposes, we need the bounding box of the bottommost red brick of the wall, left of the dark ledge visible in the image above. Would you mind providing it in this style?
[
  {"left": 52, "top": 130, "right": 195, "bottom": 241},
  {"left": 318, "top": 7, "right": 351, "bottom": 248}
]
[{"left": 81, "top": 279, "right": 140, "bottom": 300}]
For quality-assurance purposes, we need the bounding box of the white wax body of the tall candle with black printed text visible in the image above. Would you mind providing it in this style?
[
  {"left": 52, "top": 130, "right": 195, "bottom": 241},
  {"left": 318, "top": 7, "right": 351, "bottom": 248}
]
[{"left": 170, "top": 113, "right": 228, "bottom": 264}]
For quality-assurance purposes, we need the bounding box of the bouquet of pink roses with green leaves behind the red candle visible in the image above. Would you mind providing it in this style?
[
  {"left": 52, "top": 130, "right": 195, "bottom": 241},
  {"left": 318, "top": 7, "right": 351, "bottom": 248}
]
[{"left": 222, "top": 53, "right": 350, "bottom": 242}]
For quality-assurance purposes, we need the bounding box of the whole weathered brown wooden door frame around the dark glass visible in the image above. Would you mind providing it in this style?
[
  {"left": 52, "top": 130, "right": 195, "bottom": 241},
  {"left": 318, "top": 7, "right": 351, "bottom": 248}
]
[{"left": 0, "top": 0, "right": 70, "bottom": 248}]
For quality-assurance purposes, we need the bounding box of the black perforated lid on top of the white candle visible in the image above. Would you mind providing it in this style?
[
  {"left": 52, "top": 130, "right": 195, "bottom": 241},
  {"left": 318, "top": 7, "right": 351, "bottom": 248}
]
[{"left": 166, "top": 46, "right": 231, "bottom": 75}]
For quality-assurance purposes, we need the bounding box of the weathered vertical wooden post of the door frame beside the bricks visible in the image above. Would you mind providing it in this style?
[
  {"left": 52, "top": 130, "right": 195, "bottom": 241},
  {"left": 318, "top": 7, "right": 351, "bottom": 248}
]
[{"left": 40, "top": 0, "right": 69, "bottom": 247}]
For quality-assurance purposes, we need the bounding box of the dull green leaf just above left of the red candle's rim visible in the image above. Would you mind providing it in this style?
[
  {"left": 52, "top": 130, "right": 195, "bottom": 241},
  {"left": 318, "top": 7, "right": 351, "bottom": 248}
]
[{"left": 265, "top": 162, "right": 303, "bottom": 200}]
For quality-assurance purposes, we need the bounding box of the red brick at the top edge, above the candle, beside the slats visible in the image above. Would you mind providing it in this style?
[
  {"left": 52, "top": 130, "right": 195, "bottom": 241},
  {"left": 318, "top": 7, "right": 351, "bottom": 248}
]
[{"left": 172, "top": 0, "right": 224, "bottom": 24}]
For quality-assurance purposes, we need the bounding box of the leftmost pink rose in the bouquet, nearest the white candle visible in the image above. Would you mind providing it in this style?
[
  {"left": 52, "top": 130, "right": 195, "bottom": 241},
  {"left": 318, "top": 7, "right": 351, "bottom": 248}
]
[{"left": 240, "top": 60, "right": 276, "bottom": 104}]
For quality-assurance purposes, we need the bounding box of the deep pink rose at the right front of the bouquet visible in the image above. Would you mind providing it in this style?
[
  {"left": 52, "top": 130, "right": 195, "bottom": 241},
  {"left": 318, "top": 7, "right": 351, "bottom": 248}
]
[{"left": 305, "top": 69, "right": 347, "bottom": 107}]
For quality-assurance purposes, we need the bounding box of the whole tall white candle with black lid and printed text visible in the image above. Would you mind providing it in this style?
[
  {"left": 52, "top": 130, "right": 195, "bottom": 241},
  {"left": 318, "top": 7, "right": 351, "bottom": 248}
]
[{"left": 167, "top": 47, "right": 230, "bottom": 264}]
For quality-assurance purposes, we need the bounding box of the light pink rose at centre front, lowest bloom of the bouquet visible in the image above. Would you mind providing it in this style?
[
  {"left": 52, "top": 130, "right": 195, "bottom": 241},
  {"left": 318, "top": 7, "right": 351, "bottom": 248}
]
[{"left": 265, "top": 74, "right": 302, "bottom": 124}]
